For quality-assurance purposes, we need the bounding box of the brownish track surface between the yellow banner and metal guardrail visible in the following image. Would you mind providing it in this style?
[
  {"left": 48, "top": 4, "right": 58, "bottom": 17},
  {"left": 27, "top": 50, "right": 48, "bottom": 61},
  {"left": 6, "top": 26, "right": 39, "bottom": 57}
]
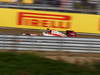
[{"left": 0, "top": 28, "right": 100, "bottom": 38}]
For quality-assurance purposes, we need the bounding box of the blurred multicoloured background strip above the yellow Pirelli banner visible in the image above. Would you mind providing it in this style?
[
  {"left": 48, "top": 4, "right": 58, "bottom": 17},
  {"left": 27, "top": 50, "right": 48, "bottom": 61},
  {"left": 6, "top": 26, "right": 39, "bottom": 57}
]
[{"left": 0, "top": 0, "right": 100, "bottom": 14}]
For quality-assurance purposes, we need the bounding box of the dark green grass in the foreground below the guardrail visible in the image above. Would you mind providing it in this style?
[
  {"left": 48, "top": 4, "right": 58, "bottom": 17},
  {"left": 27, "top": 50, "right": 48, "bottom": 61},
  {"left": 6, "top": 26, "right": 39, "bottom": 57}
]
[{"left": 0, "top": 52, "right": 100, "bottom": 75}]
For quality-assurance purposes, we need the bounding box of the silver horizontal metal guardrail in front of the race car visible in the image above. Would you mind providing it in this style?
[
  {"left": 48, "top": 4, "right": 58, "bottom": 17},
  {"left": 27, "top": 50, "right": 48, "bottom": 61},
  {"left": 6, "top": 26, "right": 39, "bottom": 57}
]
[{"left": 0, "top": 35, "right": 100, "bottom": 53}]
